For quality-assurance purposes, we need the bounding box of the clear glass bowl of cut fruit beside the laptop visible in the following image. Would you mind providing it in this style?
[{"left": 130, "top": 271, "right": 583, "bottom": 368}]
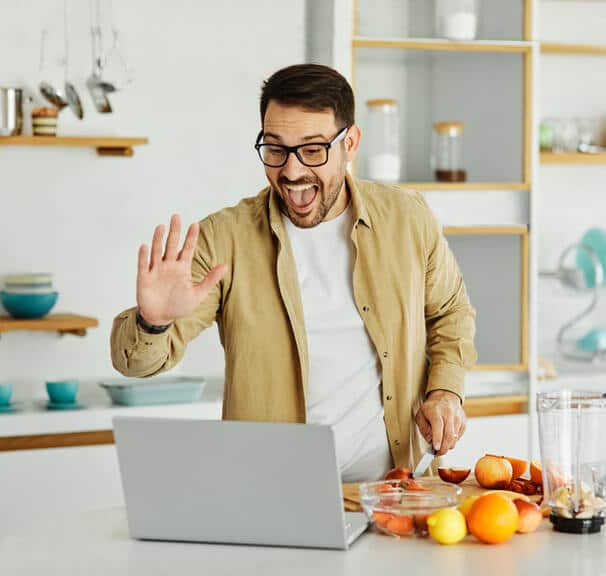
[{"left": 360, "top": 478, "right": 463, "bottom": 538}]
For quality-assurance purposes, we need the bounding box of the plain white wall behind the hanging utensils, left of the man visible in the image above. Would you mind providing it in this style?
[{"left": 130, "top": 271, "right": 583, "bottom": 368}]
[{"left": 0, "top": 0, "right": 305, "bottom": 396}]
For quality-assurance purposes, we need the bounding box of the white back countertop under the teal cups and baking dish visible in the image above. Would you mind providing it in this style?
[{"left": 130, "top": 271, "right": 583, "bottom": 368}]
[{"left": 0, "top": 379, "right": 223, "bottom": 437}]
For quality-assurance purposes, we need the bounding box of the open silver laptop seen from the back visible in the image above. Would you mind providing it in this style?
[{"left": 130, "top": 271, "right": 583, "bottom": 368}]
[{"left": 113, "top": 416, "right": 367, "bottom": 549}]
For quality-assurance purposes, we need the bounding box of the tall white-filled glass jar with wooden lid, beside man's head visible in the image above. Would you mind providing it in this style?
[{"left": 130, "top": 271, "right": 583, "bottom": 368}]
[{"left": 366, "top": 98, "right": 400, "bottom": 183}]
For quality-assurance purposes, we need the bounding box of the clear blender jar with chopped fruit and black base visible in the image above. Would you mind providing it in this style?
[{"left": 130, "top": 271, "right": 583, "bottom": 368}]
[{"left": 537, "top": 390, "right": 606, "bottom": 534}]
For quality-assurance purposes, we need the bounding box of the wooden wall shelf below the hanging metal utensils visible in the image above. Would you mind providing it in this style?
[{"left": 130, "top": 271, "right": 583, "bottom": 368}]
[{"left": 0, "top": 136, "right": 149, "bottom": 156}]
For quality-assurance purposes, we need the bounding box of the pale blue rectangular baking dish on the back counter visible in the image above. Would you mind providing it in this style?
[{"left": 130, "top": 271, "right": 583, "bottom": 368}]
[{"left": 99, "top": 376, "right": 206, "bottom": 406}]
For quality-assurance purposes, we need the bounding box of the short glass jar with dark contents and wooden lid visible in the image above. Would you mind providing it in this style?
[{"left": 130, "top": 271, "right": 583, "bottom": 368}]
[{"left": 432, "top": 122, "right": 467, "bottom": 182}]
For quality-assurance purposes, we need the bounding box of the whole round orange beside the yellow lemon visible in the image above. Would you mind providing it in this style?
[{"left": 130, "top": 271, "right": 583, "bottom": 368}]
[{"left": 467, "top": 493, "right": 519, "bottom": 544}]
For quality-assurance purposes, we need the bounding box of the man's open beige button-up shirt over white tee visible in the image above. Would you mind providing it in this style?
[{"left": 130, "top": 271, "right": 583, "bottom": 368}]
[{"left": 111, "top": 176, "right": 476, "bottom": 467}]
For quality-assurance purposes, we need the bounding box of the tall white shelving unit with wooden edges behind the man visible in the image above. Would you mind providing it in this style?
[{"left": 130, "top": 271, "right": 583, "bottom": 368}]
[{"left": 307, "top": 0, "right": 539, "bottom": 415}]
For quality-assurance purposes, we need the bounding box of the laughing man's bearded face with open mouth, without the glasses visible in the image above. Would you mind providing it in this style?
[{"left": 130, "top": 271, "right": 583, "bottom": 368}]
[{"left": 263, "top": 100, "right": 357, "bottom": 228}]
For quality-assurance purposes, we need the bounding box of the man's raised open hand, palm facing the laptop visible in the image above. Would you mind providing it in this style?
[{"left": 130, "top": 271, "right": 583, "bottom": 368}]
[{"left": 137, "top": 214, "right": 227, "bottom": 325}]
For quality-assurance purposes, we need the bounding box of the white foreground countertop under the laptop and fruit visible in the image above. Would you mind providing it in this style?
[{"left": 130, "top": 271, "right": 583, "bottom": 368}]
[{"left": 0, "top": 508, "right": 606, "bottom": 576}]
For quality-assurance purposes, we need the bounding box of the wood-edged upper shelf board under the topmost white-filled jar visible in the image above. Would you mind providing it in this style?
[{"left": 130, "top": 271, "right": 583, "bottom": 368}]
[{"left": 353, "top": 36, "right": 532, "bottom": 53}]
